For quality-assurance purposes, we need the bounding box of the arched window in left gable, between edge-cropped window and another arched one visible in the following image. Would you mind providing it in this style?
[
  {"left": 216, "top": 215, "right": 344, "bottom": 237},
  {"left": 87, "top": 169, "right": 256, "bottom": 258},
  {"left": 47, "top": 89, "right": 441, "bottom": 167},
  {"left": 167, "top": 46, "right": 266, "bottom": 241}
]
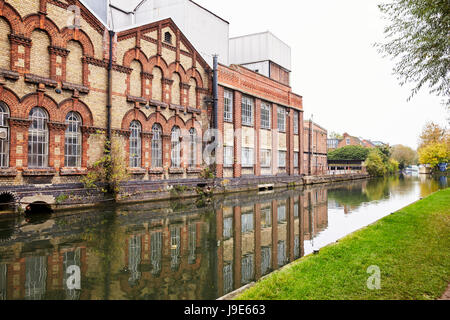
[{"left": 28, "top": 107, "right": 48, "bottom": 168}]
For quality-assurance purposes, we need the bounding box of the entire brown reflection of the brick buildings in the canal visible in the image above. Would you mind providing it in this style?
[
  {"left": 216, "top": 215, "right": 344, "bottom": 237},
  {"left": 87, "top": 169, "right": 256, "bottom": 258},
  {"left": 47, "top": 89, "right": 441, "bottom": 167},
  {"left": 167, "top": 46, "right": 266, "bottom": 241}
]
[{"left": 0, "top": 188, "right": 328, "bottom": 300}]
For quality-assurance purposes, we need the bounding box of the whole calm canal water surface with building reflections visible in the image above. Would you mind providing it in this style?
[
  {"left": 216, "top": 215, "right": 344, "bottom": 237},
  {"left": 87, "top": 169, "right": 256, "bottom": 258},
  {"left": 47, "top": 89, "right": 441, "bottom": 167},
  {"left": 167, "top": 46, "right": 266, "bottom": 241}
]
[{"left": 0, "top": 176, "right": 447, "bottom": 300}]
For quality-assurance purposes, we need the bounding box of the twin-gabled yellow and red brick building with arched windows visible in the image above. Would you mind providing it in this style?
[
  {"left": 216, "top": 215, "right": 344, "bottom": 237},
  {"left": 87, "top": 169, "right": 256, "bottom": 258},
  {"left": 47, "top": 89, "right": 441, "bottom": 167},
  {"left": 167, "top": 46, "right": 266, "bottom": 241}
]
[{"left": 0, "top": 0, "right": 210, "bottom": 188}]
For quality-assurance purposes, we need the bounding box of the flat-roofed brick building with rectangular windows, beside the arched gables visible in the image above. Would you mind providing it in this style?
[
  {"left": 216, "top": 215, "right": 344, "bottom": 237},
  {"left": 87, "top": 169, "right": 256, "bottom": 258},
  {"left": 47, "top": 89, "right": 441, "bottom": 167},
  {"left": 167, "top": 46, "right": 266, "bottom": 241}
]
[{"left": 217, "top": 65, "right": 303, "bottom": 178}]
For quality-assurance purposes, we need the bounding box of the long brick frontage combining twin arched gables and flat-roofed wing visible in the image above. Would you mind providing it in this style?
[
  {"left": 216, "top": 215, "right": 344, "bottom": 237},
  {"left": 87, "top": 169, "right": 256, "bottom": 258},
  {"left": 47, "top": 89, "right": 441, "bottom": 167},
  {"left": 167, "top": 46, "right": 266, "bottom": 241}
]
[{"left": 0, "top": 0, "right": 303, "bottom": 205}]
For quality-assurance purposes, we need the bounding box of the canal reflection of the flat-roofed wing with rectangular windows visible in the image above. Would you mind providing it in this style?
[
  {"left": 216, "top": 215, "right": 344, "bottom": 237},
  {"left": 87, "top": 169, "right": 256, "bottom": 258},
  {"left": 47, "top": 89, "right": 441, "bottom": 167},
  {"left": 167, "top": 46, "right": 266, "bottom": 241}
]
[{"left": 216, "top": 188, "right": 328, "bottom": 296}]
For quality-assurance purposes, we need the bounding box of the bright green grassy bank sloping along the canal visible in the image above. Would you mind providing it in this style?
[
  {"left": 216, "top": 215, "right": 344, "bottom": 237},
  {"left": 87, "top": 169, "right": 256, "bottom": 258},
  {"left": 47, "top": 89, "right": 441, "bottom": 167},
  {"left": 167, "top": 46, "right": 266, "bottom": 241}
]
[{"left": 238, "top": 189, "right": 450, "bottom": 300}]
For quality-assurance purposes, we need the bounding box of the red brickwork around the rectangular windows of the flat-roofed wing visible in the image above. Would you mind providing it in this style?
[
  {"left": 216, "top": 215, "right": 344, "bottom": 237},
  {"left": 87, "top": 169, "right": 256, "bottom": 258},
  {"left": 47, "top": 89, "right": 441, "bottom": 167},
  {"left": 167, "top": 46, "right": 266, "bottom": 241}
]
[{"left": 216, "top": 65, "right": 303, "bottom": 178}]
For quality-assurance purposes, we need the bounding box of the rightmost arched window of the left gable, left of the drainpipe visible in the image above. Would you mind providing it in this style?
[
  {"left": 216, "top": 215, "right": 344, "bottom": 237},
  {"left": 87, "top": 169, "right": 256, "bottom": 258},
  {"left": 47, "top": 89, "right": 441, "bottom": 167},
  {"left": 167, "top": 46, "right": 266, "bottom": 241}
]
[{"left": 64, "top": 112, "right": 82, "bottom": 168}]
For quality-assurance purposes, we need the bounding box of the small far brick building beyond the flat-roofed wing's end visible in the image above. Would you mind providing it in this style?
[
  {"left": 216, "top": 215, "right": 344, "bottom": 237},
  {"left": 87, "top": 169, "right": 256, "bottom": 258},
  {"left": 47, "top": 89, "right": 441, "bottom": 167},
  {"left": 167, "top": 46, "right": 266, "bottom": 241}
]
[{"left": 303, "top": 120, "right": 328, "bottom": 175}]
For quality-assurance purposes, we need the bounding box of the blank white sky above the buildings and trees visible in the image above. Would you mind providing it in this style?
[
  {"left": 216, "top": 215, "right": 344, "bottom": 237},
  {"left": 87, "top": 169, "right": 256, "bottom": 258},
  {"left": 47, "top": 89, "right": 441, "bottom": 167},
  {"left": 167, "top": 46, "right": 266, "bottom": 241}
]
[{"left": 194, "top": 0, "right": 448, "bottom": 149}]
